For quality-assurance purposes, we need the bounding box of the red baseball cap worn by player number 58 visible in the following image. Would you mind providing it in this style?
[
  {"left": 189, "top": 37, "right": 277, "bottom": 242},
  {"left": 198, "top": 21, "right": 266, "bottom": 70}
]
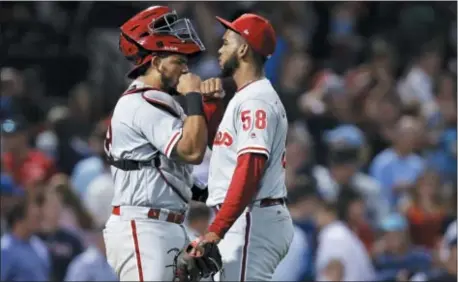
[{"left": 216, "top": 14, "right": 277, "bottom": 57}]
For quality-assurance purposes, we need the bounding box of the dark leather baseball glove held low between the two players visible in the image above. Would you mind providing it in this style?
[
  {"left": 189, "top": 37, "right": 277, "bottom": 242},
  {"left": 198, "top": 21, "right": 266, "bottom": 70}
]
[{"left": 174, "top": 243, "right": 223, "bottom": 282}]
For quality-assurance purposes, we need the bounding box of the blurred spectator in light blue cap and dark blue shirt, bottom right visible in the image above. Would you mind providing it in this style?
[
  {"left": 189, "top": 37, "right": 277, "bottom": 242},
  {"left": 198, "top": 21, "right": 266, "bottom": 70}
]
[{"left": 374, "top": 213, "right": 432, "bottom": 281}]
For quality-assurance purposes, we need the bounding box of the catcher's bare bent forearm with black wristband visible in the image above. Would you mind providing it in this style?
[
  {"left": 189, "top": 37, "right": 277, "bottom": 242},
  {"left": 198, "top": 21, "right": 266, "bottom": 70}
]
[{"left": 176, "top": 93, "right": 208, "bottom": 164}]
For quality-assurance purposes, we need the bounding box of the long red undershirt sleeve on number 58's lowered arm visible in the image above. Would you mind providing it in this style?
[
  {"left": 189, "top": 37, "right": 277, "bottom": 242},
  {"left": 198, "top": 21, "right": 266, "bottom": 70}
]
[{"left": 208, "top": 153, "right": 267, "bottom": 238}]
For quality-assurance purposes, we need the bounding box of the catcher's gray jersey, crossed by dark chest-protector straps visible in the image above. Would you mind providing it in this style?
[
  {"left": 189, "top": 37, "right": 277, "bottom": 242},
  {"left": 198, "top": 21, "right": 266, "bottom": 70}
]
[{"left": 105, "top": 81, "right": 193, "bottom": 211}]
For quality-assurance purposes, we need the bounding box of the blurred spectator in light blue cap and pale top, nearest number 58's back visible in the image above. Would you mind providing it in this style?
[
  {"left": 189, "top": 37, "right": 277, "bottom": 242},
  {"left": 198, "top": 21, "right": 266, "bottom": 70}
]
[{"left": 313, "top": 124, "right": 389, "bottom": 224}]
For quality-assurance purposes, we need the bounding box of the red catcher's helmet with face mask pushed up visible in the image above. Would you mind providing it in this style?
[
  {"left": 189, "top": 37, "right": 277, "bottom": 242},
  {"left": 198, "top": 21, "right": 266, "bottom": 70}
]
[{"left": 119, "top": 6, "right": 205, "bottom": 78}]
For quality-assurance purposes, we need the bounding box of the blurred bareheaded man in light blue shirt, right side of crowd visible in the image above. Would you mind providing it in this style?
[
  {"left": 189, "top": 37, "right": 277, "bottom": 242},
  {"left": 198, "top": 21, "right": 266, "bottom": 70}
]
[{"left": 370, "top": 117, "right": 424, "bottom": 209}]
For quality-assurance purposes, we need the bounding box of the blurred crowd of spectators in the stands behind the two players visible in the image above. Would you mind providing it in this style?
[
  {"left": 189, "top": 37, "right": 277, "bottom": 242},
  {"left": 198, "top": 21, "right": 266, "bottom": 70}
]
[{"left": 0, "top": 1, "right": 457, "bottom": 281}]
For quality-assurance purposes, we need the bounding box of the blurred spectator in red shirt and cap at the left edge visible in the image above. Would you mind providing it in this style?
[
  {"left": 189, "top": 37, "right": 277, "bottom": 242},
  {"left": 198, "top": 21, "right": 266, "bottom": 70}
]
[{"left": 1, "top": 117, "right": 56, "bottom": 190}]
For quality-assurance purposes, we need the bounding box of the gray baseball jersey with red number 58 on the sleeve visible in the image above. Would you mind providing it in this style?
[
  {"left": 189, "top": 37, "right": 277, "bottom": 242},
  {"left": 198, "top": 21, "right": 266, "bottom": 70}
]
[{"left": 207, "top": 78, "right": 288, "bottom": 206}]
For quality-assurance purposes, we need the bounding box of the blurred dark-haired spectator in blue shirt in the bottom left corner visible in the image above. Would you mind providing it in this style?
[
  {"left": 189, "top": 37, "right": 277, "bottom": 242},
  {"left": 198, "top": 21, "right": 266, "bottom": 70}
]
[{"left": 0, "top": 195, "right": 51, "bottom": 281}]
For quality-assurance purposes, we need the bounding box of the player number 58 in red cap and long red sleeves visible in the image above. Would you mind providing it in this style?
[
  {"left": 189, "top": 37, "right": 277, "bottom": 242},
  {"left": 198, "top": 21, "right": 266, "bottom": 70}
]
[{"left": 190, "top": 14, "right": 294, "bottom": 281}]
